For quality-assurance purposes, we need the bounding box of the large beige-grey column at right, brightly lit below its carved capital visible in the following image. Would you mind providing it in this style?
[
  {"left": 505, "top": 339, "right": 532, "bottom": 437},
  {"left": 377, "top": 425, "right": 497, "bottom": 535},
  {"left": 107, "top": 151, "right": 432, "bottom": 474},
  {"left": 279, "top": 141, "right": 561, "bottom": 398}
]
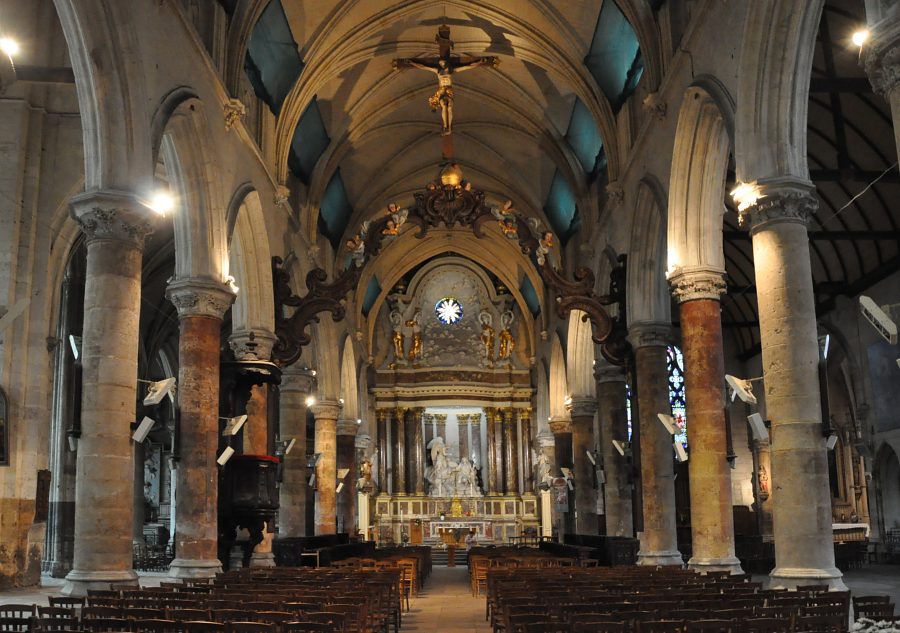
[{"left": 744, "top": 185, "right": 846, "bottom": 590}]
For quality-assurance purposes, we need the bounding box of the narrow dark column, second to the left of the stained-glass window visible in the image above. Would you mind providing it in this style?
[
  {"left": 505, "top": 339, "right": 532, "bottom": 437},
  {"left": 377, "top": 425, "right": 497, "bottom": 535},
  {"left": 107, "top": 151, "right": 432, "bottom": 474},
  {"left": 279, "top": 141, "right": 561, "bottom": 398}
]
[{"left": 567, "top": 396, "right": 599, "bottom": 534}]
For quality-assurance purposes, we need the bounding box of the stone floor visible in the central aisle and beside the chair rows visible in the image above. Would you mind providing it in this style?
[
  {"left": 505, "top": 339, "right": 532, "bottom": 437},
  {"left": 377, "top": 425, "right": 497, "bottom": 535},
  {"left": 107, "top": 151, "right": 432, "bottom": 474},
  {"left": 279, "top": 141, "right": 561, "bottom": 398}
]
[{"left": 0, "top": 565, "right": 900, "bottom": 633}]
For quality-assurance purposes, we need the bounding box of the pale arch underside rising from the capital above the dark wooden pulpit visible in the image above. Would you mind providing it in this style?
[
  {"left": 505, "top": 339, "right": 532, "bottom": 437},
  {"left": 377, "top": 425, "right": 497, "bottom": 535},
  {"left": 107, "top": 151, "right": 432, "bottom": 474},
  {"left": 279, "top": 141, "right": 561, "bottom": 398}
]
[{"left": 228, "top": 185, "right": 275, "bottom": 348}]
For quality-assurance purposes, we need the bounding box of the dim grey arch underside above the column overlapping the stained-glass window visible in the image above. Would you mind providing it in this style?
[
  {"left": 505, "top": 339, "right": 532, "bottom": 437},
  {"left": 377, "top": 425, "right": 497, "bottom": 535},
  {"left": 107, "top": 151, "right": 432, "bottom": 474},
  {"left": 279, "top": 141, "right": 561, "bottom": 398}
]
[{"left": 626, "top": 176, "right": 671, "bottom": 327}]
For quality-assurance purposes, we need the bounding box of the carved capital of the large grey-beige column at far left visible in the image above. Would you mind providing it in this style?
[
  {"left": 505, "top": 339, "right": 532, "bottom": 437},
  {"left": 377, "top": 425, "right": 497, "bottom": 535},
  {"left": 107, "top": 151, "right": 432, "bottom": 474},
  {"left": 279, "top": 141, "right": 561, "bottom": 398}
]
[{"left": 69, "top": 190, "right": 153, "bottom": 249}]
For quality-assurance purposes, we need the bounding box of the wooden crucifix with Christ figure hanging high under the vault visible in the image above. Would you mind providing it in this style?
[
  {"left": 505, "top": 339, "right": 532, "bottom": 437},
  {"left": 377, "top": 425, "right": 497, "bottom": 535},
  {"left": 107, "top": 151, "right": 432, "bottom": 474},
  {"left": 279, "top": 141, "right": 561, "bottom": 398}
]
[{"left": 393, "top": 24, "right": 500, "bottom": 157}]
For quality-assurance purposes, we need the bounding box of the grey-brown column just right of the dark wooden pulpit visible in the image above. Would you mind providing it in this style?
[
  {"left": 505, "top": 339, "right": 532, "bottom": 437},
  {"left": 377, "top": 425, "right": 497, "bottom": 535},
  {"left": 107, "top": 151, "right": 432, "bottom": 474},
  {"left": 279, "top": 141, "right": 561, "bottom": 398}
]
[{"left": 278, "top": 367, "right": 315, "bottom": 538}]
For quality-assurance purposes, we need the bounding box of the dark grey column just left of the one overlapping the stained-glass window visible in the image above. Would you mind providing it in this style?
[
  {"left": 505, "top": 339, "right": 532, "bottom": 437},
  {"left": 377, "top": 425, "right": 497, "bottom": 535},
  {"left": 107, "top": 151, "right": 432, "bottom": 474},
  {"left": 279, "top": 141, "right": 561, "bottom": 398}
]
[{"left": 594, "top": 360, "right": 634, "bottom": 538}]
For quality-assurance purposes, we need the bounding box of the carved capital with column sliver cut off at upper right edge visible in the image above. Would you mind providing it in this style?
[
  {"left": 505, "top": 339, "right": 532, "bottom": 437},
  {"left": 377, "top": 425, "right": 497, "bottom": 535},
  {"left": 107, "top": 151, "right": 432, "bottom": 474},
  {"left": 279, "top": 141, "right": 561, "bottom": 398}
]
[{"left": 863, "top": 18, "right": 900, "bottom": 163}]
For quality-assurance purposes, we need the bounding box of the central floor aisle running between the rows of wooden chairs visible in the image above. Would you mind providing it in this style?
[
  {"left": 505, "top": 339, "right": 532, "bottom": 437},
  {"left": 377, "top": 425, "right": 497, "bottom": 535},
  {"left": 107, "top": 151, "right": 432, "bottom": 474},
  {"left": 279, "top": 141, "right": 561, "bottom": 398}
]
[{"left": 400, "top": 567, "right": 491, "bottom": 633}]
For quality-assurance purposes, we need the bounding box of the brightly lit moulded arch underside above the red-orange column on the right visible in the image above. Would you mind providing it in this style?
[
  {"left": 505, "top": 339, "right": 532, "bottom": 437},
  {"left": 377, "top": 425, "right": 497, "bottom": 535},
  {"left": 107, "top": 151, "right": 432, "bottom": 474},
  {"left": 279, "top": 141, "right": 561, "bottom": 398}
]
[{"left": 666, "top": 86, "right": 730, "bottom": 276}]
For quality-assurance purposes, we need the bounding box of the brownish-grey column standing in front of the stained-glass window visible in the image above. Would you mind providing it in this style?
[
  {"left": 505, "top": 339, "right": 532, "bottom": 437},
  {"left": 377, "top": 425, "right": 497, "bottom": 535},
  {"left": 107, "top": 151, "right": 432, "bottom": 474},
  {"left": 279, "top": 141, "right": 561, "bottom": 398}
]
[{"left": 628, "top": 323, "right": 682, "bottom": 566}]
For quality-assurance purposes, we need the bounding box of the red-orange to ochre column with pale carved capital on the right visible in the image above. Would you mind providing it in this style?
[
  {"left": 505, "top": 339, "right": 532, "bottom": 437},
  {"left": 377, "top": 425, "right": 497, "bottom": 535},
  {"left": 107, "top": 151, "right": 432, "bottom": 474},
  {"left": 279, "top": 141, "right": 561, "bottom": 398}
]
[{"left": 669, "top": 270, "right": 743, "bottom": 574}]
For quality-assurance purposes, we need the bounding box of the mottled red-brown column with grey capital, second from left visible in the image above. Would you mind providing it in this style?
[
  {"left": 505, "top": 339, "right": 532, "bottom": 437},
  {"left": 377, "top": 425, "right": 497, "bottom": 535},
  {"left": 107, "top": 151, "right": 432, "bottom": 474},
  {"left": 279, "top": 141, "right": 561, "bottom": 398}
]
[{"left": 166, "top": 279, "right": 234, "bottom": 578}]
